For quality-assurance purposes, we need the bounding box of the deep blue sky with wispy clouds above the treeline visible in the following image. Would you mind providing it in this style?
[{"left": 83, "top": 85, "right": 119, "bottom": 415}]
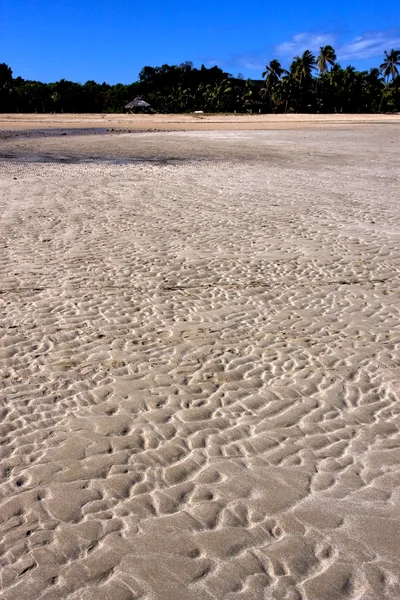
[{"left": 0, "top": 0, "right": 400, "bottom": 84}]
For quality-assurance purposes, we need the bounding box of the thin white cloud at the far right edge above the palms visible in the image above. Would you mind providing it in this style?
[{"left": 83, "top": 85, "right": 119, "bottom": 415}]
[{"left": 337, "top": 30, "right": 400, "bottom": 60}]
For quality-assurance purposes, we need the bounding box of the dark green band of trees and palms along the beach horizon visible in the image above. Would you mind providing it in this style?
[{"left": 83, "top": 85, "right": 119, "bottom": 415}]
[{"left": 0, "top": 46, "right": 400, "bottom": 113}]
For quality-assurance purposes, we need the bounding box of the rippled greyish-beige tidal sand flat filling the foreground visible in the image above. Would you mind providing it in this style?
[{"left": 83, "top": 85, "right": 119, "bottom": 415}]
[{"left": 0, "top": 117, "right": 400, "bottom": 600}]
